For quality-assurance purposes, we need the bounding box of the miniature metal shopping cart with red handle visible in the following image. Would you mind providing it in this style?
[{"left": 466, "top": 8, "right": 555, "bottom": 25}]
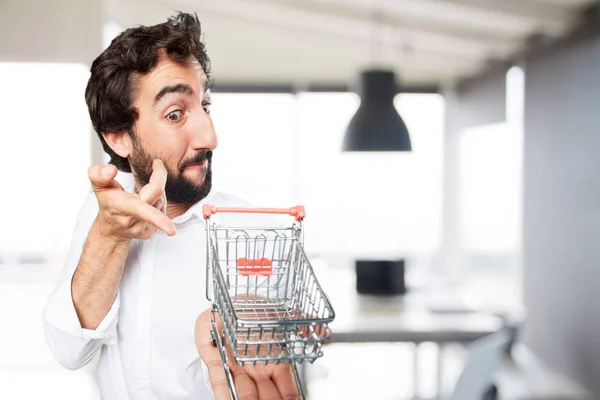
[{"left": 202, "top": 205, "right": 335, "bottom": 399}]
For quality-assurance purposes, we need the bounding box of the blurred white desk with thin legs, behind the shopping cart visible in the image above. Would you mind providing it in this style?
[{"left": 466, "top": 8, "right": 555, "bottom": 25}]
[{"left": 311, "top": 259, "right": 503, "bottom": 392}]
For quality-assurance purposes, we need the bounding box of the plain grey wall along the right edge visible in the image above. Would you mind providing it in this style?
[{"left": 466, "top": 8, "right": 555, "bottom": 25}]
[{"left": 523, "top": 29, "right": 600, "bottom": 396}]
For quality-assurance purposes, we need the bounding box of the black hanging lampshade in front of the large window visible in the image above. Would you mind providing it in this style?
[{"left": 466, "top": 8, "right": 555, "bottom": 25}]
[{"left": 342, "top": 70, "right": 412, "bottom": 151}]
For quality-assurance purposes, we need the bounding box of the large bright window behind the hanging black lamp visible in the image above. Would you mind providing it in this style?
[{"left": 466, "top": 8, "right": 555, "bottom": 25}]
[{"left": 212, "top": 93, "right": 444, "bottom": 256}]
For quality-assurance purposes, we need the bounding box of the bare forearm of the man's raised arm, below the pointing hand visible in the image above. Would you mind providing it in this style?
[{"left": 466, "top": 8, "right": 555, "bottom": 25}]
[{"left": 71, "top": 219, "right": 131, "bottom": 330}]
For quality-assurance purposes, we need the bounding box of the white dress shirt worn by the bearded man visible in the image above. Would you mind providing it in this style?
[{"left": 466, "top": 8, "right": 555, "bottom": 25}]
[{"left": 44, "top": 188, "right": 272, "bottom": 400}]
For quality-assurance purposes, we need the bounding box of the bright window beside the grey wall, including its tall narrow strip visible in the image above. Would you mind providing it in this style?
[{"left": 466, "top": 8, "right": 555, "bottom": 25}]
[{"left": 458, "top": 68, "right": 524, "bottom": 312}]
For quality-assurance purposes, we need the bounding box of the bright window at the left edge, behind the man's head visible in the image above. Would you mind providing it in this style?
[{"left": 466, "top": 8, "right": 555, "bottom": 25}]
[{"left": 0, "top": 63, "right": 92, "bottom": 255}]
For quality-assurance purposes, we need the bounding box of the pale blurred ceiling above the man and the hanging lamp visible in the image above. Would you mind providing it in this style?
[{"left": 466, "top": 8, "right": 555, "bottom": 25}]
[{"left": 107, "top": 0, "right": 595, "bottom": 87}]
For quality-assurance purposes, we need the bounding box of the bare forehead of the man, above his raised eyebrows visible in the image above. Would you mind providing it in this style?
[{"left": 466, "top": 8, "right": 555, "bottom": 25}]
[{"left": 135, "top": 53, "right": 207, "bottom": 101}]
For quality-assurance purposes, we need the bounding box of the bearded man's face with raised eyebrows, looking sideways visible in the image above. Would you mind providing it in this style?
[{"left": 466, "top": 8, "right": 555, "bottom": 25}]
[{"left": 129, "top": 54, "right": 217, "bottom": 204}]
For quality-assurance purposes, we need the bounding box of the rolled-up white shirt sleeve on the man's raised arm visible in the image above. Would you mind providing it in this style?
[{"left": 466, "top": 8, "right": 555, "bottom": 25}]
[{"left": 43, "top": 194, "right": 120, "bottom": 369}]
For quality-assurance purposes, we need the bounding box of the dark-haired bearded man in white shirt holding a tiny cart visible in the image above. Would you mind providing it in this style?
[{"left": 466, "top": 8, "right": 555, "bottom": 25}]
[{"left": 44, "top": 13, "right": 298, "bottom": 400}]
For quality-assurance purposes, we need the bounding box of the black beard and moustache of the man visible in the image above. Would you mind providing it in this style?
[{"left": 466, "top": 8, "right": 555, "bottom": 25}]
[{"left": 129, "top": 141, "right": 212, "bottom": 205}]
